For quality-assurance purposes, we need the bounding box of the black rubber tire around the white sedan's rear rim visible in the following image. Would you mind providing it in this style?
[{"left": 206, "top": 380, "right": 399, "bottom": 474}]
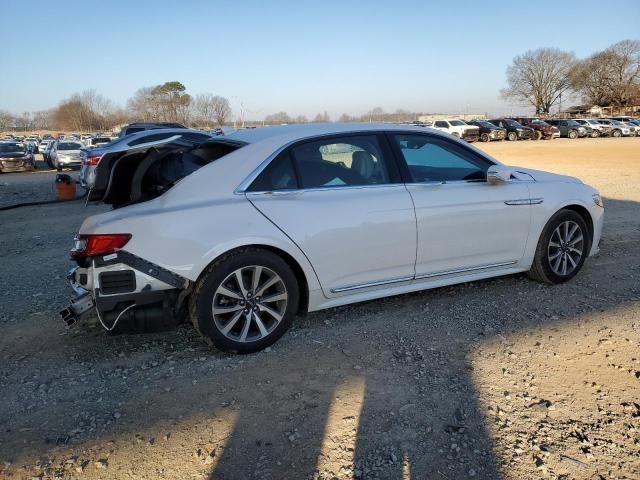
[{"left": 189, "top": 248, "right": 300, "bottom": 353}]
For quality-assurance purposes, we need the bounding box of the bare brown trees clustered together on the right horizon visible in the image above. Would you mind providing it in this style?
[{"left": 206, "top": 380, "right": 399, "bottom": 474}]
[{"left": 501, "top": 40, "right": 640, "bottom": 114}]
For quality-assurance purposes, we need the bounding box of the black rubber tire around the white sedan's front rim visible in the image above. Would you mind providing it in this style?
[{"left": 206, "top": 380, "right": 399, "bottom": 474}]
[{"left": 527, "top": 210, "right": 591, "bottom": 285}]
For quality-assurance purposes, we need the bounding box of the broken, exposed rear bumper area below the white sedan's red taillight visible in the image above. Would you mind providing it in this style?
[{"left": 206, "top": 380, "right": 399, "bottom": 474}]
[{"left": 60, "top": 250, "right": 191, "bottom": 331}]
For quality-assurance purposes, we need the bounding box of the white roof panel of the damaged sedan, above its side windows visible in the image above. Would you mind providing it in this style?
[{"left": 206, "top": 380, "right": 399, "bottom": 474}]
[{"left": 222, "top": 123, "right": 451, "bottom": 144}]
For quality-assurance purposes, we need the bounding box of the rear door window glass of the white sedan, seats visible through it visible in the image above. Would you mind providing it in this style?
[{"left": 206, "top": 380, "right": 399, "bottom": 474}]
[{"left": 291, "top": 135, "right": 389, "bottom": 188}]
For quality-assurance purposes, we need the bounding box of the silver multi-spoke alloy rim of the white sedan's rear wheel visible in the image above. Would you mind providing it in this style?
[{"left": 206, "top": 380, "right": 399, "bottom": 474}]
[{"left": 212, "top": 265, "right": 288, "bottom": 343}]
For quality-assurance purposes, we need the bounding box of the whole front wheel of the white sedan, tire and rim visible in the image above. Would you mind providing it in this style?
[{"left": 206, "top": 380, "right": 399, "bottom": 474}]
[{"left": 528, "top": 210, "right": 591, "bottom": 284}]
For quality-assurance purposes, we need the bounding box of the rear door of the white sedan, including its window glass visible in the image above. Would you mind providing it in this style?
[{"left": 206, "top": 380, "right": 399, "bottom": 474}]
[{"left": 246, "top": 134, "right": 416, "bottom": 297}]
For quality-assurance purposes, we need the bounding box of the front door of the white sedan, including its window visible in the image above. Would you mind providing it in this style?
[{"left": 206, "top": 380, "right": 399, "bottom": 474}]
[{"left": 390, "top": 133, "right": 531, "bottom": 279}]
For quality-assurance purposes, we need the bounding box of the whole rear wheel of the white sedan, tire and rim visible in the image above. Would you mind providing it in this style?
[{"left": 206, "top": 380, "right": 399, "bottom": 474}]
[{"left": 189, "top": 248, "right": 299, "bottom": 353}]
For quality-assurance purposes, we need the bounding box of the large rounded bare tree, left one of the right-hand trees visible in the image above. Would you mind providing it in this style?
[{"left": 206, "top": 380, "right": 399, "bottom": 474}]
[{"left": 500, "top": 48, "right": 576, "bottom": 114}]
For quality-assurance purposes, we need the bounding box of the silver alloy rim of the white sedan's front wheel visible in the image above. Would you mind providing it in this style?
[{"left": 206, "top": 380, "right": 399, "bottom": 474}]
[{"left": 547, "top": 220, "right": 585, "bottom": 277}]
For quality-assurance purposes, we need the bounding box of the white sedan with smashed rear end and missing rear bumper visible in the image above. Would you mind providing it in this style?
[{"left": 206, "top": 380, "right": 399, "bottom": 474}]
[{"left": 61, "top": 124, "right": 604, "bottom": 353}]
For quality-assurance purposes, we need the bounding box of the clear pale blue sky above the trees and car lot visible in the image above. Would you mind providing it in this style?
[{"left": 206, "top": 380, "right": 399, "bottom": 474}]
[{"left": 0, "top": 0, "right": 640, "bottom": 119}]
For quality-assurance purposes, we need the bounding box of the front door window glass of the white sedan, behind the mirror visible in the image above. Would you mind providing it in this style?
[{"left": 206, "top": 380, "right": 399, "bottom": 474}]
[{"left": 393, "top": 135, "right": 491, "bottom": 183}]
